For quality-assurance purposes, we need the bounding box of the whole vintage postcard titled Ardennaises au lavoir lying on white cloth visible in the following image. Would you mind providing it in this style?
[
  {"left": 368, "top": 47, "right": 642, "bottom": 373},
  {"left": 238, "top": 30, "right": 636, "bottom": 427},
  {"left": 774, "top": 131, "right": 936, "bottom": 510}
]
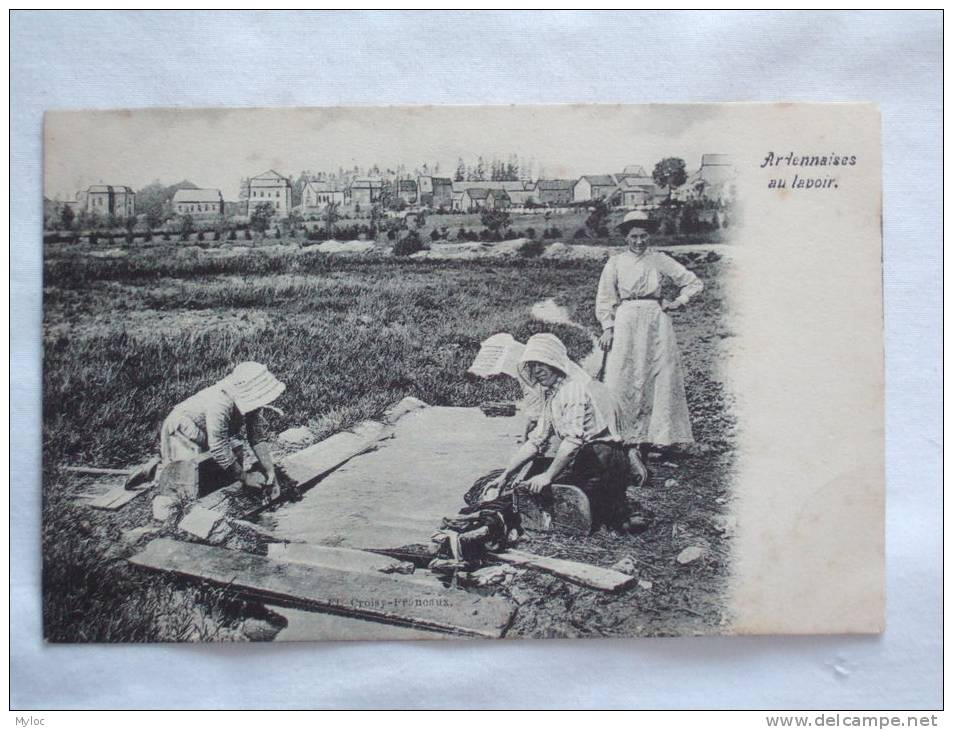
[{"left": 42, "top": 104, "right": 885, "bottom": 642}]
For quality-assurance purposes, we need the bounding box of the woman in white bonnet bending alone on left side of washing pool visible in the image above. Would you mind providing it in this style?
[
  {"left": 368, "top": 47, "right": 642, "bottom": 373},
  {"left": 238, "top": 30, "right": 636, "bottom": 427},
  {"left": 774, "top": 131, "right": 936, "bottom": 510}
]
[{"left": 160, "top": 362, "right": 285, "bottom": 496}]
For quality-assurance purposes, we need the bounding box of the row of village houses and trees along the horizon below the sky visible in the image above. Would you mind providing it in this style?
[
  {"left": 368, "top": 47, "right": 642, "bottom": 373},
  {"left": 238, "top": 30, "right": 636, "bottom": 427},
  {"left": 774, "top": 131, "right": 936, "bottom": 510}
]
[{"left": 44, "top": 154, "right": 737, "bottom": 255}]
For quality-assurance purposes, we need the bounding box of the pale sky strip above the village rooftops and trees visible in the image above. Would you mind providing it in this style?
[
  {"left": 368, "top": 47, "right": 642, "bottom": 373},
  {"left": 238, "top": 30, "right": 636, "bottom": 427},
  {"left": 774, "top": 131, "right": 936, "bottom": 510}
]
[{"left": 44, "top": 104, "right": 725, "bottom": 200}]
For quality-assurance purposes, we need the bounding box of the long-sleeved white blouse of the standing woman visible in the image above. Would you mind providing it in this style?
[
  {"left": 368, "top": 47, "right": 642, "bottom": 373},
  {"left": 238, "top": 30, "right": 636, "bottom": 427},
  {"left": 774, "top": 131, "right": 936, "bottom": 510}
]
[{"left": 596, "top": 251, "right": 705, "bottom": 329}]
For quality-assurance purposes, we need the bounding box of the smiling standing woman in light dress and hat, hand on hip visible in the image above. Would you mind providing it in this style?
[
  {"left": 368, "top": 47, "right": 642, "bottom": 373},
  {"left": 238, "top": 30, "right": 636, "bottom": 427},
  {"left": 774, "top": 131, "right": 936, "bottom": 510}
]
[{"left": 596, "top": 211, "right": 704, "bottom": 461}]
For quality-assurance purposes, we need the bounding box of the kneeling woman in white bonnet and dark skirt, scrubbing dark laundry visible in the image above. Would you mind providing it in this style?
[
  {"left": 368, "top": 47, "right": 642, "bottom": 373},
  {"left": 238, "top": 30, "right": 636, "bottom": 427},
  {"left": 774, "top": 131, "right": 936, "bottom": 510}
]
[{"left": 484, "top": 334, "right": 630, "bottom": 531}]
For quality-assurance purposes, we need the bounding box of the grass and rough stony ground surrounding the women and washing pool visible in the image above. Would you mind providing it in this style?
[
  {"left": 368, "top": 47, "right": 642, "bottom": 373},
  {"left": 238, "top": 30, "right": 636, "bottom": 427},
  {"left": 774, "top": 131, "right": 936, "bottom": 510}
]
[{"left": 43, "top": 239, "right": 731, "bottom": 641}]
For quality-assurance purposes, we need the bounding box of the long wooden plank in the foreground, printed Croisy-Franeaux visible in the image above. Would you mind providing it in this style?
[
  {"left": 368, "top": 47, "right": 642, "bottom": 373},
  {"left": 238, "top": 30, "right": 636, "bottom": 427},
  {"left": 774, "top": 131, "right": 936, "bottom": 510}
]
[{"left": 129, "top": 538, "right": 516, "bottom": 638}]
